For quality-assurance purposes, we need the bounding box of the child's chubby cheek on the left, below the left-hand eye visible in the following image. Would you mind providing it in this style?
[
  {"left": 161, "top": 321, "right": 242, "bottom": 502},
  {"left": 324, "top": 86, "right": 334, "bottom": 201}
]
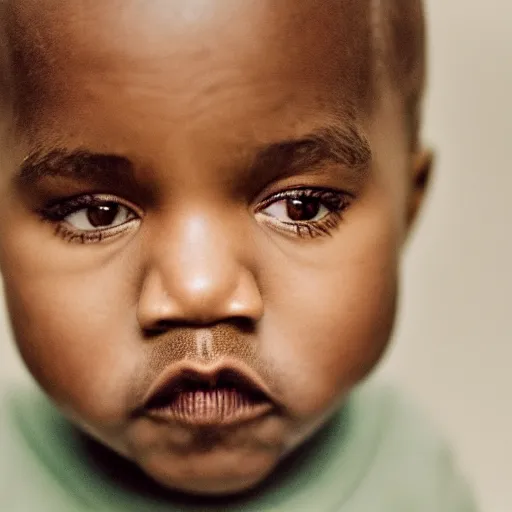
[{"left": 4, "top": 262, "right": 140, "bottom": 428}]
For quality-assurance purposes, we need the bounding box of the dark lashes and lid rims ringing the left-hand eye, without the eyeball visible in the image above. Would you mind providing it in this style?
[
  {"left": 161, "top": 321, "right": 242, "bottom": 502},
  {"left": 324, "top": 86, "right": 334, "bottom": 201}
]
[{"left": 38, "top": 194, "right": 141, "bottom": 244}]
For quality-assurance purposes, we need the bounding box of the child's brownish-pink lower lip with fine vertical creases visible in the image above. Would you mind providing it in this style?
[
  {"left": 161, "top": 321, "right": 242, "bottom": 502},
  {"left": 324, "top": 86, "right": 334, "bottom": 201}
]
[{"left": 148, "top": 389, "right": 273, "bottom": 426}]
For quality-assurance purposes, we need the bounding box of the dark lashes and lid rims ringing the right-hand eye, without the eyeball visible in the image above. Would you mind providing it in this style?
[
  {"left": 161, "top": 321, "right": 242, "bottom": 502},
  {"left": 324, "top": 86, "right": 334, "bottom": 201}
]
[{"left": 257, "top": 188, "right": 352, "bottom": 238}]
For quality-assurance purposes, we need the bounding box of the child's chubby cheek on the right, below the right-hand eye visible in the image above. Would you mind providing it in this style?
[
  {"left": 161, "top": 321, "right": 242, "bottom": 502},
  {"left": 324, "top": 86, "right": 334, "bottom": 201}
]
[{"left": 263, "top": 192, "right": 400, "bottom": 421}]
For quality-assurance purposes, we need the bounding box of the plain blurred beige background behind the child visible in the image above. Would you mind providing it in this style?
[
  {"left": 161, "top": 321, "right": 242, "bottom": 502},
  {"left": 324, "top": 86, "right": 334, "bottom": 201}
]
[{"left": 0, "top": 0, "right": 512, "bottom": 512}]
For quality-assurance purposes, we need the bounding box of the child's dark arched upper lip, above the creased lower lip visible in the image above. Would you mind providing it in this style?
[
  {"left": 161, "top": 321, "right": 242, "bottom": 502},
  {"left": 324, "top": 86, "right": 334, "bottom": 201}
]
[{"left": 143, "top": 362, "right": 275, "bottom": 410}]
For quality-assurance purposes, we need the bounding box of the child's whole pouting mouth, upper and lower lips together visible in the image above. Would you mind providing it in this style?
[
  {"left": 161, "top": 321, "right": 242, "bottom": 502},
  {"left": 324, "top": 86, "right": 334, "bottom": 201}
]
[{"left": 142, "top": 362, "right": 276, "bottom": 427}]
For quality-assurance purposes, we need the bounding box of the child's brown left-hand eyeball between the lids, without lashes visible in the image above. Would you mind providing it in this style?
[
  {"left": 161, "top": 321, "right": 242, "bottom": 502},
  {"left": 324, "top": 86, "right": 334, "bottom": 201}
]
[{"left": 63, "top": 202, "right": 137, "bottom": 231}]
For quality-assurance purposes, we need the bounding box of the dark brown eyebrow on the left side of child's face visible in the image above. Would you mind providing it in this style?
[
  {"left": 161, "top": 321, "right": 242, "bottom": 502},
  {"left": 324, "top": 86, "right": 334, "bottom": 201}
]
[{"left": 16, "top": 148, "right": 133, "bottom": 185}]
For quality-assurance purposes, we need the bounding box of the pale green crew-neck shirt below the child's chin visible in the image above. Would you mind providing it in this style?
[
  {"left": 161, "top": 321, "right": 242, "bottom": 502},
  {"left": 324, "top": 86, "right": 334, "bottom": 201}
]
[{"left": 0, "top": 383, "right": 476, "bottom": 512}]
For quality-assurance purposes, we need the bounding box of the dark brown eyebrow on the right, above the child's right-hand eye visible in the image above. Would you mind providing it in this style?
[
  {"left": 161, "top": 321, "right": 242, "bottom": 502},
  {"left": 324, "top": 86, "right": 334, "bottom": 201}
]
[{"left": 254, "top": 126, "right": 372, "bottom": 178}]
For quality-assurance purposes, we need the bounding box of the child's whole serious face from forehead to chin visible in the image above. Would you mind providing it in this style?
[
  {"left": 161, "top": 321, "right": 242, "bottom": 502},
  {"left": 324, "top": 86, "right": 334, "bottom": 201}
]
[{"left": 0, "top": 0, "right": 424, "bottom": 493}]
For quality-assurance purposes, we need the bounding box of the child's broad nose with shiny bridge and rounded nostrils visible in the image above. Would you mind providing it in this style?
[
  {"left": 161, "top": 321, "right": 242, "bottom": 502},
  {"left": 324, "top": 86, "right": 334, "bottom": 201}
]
[{"left": 137, "top": 216, "right": 263, "bottom": 332}]
